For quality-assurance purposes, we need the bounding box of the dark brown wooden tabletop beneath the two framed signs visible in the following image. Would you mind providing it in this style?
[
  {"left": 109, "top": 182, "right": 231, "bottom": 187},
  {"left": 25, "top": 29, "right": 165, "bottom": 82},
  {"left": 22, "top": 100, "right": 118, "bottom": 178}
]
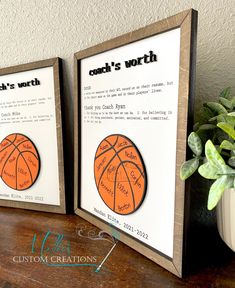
[{"left": 0, "top": 208, "right": 235, "bottom": 288}]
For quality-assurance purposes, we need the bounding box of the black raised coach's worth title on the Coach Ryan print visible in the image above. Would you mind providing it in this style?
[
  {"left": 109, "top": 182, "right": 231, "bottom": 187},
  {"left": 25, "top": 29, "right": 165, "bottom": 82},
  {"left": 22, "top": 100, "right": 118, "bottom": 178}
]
[{"left": 89, "top": 50, "right": 158, "bottom": 76}]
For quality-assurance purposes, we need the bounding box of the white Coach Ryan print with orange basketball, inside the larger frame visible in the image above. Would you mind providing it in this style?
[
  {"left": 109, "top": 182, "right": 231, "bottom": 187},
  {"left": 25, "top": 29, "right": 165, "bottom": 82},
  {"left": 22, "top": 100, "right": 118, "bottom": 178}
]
[{"left": 80, "top": 28, "right": 180, "bottom": 258}]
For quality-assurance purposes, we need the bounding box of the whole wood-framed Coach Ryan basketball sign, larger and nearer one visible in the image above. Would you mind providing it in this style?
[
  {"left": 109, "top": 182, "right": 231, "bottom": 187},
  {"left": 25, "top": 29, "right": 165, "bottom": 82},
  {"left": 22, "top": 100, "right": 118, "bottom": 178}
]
[{"left": 75, "top": 10, "right": 197, "bottom": 277}]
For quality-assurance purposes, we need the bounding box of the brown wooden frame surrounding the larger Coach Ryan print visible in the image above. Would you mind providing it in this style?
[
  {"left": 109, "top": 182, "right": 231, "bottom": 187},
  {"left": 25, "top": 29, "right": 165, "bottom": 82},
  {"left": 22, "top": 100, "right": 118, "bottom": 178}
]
[{"left": 74, "top": 9, "right": 197, "bottom": 277}]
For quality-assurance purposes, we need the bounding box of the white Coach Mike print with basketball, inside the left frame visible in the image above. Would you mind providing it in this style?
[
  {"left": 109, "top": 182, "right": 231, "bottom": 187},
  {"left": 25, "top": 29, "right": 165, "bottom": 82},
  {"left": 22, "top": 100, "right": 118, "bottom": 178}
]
[{"left": 0, "top": 59, "right": 64, "bottom": 210}]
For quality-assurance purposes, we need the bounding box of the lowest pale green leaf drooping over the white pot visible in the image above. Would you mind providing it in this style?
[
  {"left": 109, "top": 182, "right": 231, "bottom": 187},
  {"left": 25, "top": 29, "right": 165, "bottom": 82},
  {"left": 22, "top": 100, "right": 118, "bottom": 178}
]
[{"left": 207, "top": 175, "right": 234, "bottom": 210}]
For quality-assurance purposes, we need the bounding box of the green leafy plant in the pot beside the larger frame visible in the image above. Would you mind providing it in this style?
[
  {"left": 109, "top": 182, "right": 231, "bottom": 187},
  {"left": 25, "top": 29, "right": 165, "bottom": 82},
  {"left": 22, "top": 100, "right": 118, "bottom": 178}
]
[{"left": 180, "top": 87, "right": 235, "bottom": 210}]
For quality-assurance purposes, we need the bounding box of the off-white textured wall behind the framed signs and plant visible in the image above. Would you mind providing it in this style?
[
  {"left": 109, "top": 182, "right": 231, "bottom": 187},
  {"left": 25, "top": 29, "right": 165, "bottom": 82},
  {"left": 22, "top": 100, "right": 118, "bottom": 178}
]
[{"left": 0, "top": 0, "right": 235, "bottom": 107}]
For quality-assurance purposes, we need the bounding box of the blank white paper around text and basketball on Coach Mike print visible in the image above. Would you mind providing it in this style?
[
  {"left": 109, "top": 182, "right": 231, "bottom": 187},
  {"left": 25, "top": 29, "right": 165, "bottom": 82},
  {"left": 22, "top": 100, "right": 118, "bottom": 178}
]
[{"left": 0, "top": 67, "right": 60, "bottom": 205}]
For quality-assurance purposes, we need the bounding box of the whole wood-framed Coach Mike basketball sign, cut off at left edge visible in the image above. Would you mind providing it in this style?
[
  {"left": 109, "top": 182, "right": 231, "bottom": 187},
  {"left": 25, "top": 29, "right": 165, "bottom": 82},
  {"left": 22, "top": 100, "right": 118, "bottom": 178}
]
[{"left": 0, "top": 58, "right": 66, "bottom": 214}]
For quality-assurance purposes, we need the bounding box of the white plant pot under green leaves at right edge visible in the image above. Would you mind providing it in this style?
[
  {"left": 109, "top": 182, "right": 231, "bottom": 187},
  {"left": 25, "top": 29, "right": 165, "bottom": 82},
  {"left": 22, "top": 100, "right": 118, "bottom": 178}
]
[{"left": 216, "top": 189, "right": 235, "bottom": 252}]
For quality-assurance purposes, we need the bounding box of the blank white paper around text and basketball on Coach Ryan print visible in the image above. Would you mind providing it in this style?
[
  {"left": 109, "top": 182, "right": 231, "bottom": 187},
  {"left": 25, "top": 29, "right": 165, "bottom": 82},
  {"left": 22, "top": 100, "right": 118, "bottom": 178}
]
[{"left": 81, "top": 29, "right": 180, "bottom": 257}]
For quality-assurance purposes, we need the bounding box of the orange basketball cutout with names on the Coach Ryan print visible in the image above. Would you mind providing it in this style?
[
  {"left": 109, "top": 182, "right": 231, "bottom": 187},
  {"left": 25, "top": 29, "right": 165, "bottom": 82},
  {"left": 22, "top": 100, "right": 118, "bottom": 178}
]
[{"left": 94, "top": 134, "right": 147, "bottom": 215}]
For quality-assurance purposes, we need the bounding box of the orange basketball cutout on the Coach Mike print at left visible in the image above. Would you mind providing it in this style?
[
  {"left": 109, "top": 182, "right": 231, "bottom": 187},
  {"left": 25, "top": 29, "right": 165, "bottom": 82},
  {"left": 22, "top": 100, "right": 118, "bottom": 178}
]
[{"left": 0, "top": 134, "right": 40, "bottom": 190}]
